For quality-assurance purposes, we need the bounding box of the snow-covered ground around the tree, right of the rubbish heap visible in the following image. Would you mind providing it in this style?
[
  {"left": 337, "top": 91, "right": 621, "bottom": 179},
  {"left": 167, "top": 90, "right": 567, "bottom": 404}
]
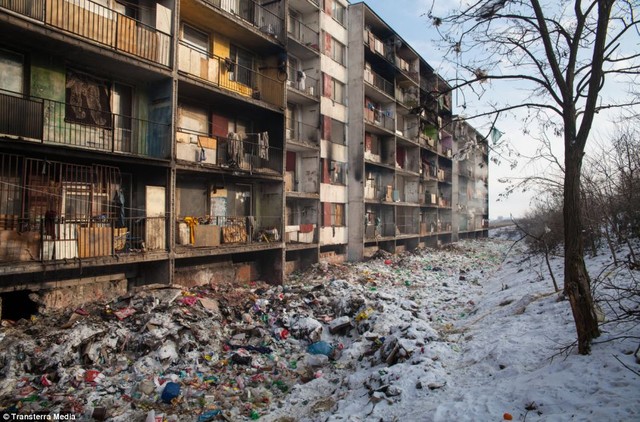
[{"left": 264, "top": 236, "right": 640, "bottom": 422}]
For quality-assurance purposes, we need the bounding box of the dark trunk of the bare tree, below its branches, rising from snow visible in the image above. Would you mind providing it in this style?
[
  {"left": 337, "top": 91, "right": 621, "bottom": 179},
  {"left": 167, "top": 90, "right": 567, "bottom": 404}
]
[{"left": 563, "top": 142, "right": 600, "bottom": 355}]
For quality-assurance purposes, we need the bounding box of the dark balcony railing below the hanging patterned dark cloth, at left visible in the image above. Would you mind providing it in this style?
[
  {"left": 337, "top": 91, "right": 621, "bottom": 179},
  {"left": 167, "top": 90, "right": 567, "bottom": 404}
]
[{"left": 0, "top": 92, "right": 170, "bottom": 158}]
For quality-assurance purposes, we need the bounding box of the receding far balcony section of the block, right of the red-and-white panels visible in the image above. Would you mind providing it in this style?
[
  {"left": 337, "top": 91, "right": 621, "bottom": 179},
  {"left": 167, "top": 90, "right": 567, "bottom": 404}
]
[{"left": 348, "top": 3, "right": 486, "bottom": 260}]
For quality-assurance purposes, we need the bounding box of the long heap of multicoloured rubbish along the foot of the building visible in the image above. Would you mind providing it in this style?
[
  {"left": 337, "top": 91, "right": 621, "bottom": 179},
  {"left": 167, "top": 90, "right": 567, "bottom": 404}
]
[{"left": 0, "top": 242, "right": 510, "bottom": 422}]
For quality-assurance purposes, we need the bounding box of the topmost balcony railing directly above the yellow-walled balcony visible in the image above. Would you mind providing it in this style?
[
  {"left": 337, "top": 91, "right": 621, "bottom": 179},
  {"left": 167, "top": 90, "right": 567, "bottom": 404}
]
[{"left": 205, "top": 0, "right": 284, "bottom": 43}]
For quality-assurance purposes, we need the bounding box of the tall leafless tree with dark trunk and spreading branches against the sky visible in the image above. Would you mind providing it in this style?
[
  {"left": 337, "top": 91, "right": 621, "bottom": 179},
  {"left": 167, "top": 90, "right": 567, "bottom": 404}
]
[{"left": 431, "top": 0, "right": 640, "bottom": 354}]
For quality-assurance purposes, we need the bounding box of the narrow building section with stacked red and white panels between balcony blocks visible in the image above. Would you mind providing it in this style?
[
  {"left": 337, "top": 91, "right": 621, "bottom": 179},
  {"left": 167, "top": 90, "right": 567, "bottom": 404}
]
[{"left": 285, "top": 0, "right": 348, "bottom": 274}]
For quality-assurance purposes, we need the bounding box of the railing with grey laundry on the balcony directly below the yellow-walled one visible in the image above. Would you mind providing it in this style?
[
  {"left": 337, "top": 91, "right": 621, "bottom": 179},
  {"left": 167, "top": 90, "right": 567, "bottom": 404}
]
[{"left": 176, "top": 128, "right": 283, "bottom": 175}]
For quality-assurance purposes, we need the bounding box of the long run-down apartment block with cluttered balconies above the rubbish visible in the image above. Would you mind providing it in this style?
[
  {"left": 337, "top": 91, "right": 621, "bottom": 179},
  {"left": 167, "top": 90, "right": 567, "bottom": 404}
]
[{"left": 0, "top": 0, "right": 487, "bottom": 314}]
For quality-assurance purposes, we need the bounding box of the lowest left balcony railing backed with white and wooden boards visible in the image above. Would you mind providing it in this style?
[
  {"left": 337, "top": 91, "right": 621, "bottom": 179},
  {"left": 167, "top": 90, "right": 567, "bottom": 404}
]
[{"left": 0, "top": 216, "right": 166, "bottom": 263}]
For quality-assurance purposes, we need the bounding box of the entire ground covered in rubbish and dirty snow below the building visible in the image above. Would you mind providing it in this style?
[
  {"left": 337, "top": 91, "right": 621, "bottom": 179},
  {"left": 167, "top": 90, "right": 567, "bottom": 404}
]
[{"left": 0, "top": 232, "right": 640, "bottom": 422}]
